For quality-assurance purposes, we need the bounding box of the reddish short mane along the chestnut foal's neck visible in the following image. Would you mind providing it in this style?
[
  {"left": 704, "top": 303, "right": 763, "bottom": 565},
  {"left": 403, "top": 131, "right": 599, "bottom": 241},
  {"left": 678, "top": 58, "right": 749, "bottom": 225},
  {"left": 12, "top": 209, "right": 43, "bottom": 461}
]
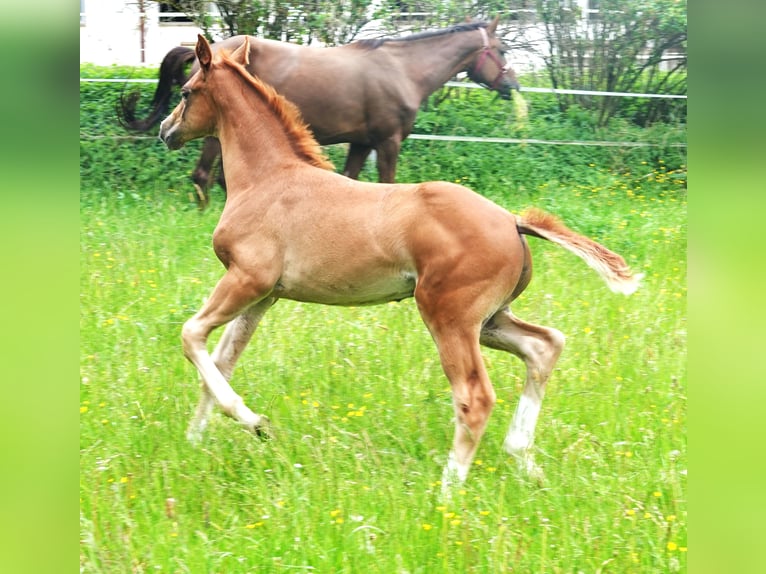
[{"left": 220, "top": 50, "right": 335, "bottom": 171}]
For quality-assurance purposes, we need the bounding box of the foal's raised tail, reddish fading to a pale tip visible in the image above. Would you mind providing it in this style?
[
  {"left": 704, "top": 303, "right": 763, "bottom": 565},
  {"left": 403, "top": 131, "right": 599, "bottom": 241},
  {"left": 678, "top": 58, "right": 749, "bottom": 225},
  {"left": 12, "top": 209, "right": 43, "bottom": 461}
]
[{"left": 516, "top": 209, "right": 643, "bottom": 295}]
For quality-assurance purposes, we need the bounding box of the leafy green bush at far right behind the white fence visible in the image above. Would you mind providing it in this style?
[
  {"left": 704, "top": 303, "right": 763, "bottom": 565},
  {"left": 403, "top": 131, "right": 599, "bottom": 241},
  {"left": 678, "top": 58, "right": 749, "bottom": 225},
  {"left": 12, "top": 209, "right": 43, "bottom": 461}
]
[{"left": 537, "top": 0, "right": 687, "bottom": 126}]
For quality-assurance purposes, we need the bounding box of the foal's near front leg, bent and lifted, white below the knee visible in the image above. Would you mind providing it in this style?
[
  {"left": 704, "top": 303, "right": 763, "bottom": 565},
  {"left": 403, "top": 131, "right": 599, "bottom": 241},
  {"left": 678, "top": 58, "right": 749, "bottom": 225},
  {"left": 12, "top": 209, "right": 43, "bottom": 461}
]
[{"left": 181, "top": 267, "right": 273, "bottom": 433}]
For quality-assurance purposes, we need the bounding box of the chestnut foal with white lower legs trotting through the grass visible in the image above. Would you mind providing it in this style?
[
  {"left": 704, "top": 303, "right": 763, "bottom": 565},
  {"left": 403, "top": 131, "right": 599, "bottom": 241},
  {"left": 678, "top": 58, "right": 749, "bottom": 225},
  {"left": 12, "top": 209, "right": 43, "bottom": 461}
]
[{"left": 160, "top": 36, "right": 640, "bottom": 488}]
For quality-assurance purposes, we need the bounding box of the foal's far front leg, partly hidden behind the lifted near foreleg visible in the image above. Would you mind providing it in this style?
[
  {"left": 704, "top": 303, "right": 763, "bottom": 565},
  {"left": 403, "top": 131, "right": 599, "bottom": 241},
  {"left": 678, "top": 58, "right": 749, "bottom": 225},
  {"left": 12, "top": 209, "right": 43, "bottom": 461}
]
[{"left": 186, "top": 298, "right": 276, "bottom": 442}]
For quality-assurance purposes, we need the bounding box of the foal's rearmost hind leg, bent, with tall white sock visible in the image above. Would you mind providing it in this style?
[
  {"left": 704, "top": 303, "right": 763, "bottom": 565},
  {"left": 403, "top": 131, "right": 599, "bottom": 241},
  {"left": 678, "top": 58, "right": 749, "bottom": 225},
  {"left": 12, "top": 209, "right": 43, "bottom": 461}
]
[{"left": 480, "top": 308, "right": 564, "bottom": 480}]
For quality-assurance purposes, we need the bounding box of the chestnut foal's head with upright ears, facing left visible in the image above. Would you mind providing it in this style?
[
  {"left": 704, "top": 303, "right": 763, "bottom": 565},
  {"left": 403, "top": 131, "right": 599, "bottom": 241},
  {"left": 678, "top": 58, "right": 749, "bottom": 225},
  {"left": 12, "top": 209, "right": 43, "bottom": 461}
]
[{"left": 160, "top": 35, "right": 250, "bottom": 149}]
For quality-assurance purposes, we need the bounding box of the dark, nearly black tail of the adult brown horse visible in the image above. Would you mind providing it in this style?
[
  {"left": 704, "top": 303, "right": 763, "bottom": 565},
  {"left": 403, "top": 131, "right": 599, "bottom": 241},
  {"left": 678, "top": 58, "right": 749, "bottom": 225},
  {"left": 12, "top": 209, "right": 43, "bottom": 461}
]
[{"left": 117, "top": 46, "right": 195, "bottom": 132}]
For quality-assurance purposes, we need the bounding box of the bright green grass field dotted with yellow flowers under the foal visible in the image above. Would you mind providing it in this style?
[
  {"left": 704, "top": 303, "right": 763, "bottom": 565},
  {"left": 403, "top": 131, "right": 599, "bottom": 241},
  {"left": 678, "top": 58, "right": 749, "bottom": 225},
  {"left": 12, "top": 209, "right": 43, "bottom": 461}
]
[{"left": 80, "top": 143, "right": 687, "bottom": 574}]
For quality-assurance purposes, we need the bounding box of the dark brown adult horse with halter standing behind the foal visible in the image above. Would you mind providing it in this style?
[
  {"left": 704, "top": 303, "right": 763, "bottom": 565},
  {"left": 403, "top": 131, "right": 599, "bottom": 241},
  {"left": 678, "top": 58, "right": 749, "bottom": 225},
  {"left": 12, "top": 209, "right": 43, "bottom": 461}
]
[{"left": 123, "top": 18, "right": 519, "bottom": 204}]
